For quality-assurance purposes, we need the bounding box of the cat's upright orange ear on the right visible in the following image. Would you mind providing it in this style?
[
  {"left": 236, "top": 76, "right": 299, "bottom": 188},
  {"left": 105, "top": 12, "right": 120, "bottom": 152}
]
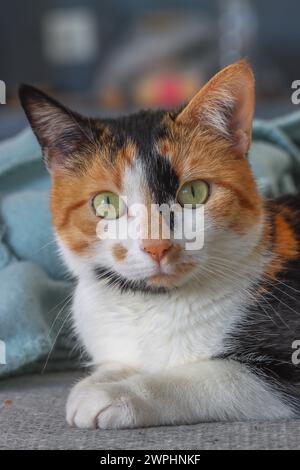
[{"left": 177, "top": 60, "right": 255, "bottom": 154}]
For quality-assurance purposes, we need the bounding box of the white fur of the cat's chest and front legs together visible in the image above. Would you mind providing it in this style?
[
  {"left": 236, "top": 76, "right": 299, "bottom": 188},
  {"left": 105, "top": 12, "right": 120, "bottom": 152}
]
[{"left": 59, "top": 226, "right": 292, "bottom": 428}]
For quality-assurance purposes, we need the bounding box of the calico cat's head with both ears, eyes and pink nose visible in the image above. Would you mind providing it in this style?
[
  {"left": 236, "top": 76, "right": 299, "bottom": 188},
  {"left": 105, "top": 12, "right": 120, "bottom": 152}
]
[{"left": 20, "top": 62, "right": 262, "bottom": 292}]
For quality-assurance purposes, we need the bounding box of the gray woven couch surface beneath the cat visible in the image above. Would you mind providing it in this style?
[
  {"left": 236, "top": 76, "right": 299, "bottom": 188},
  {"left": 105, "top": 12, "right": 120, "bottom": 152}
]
[{"left": 0, "top": 372, "right": 300, "bottom": 450}]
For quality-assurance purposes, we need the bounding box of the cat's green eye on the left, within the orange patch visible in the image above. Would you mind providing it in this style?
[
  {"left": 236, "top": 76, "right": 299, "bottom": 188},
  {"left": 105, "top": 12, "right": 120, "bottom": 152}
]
[{"left": 92, "top": 192, "right": 126, "bottom": 219}]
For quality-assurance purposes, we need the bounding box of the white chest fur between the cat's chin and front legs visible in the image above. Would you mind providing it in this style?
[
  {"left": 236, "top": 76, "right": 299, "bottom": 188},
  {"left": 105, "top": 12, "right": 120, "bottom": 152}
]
[{"left": 73, "top": 280, "right": 245, "bottom": 371}]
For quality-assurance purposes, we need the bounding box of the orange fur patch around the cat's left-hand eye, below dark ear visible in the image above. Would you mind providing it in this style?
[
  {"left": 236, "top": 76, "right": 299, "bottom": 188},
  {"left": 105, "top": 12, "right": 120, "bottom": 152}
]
[{"left": 51, "top": 143, "right": 135, "bottom": 254}]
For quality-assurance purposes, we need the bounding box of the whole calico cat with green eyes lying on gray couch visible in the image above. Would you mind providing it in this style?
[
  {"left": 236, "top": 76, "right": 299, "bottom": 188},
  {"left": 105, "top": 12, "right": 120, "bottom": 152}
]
[{"left": 20, "top": 61, "right": 300, "bottom": 429}]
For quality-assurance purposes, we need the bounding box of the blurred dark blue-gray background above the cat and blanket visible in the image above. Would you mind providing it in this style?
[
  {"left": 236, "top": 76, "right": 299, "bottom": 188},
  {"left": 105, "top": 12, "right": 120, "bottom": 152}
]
[{"left": 0, "top": 0, "right": 300, "bottom": 139}]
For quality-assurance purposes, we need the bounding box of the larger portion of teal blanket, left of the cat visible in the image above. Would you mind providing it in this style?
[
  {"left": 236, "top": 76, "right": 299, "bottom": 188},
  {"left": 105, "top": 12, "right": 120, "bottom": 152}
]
[{"left": 0, "top": 129, "right": 77, "bottom": 377}]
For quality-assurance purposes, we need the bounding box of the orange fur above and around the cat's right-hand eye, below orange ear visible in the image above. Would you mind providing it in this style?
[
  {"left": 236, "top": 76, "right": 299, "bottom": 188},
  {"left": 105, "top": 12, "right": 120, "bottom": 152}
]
[{"left": 157, "top": 119, "right": 263, "bottom": 233}]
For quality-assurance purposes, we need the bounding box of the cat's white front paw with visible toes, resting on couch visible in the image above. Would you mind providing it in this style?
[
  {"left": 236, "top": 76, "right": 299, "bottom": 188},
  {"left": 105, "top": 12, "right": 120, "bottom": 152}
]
[{"left": 67, "top": 379, "right": 144, "bottom": 429}]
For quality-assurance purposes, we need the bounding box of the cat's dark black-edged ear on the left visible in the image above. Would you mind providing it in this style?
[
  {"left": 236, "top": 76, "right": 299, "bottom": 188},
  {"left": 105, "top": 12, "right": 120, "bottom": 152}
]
[{"left": 19, "top": 85, "right": 93, "bottom": 172}]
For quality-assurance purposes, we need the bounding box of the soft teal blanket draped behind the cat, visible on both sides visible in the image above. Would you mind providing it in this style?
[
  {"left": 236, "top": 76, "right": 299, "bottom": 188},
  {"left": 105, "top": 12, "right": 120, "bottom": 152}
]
[{"left": 0, "top": 113, "right": 300, "bottom": 377}]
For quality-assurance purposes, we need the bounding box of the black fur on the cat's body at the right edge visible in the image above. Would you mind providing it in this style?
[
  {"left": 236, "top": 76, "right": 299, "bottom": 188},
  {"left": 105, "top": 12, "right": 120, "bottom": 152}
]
[{"left": 220, "top": 197, "right": 300, "bottom": 413}]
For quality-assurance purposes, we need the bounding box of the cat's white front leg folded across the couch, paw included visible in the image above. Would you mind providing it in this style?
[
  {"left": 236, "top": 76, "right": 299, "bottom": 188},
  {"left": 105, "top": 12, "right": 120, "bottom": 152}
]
[{"left": 65, "top": 360, "right": 293, "bottom": 429}]
